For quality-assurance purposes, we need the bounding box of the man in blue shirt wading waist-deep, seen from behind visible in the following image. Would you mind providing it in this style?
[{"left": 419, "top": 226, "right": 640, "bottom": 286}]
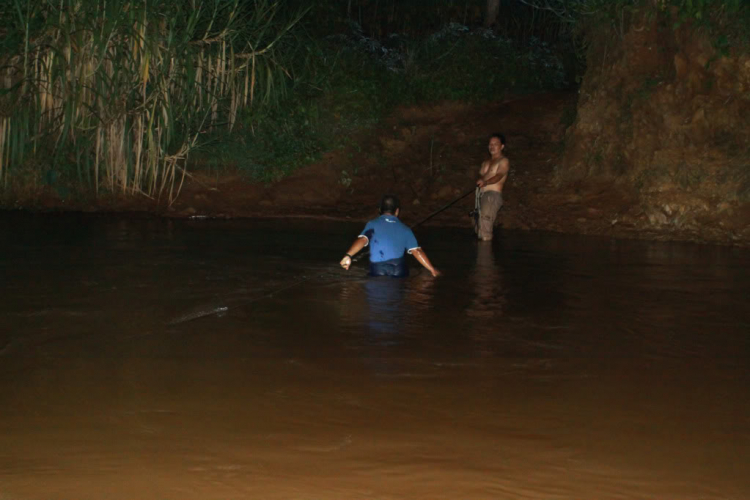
[{"left": 340, "top": 194, "right": 440, "bottom": 278}]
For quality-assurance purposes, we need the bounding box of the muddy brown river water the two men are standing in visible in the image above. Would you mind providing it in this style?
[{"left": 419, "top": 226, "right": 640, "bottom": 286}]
[{"left": 0, "top": 214, "right": 750, "bottom": 500}]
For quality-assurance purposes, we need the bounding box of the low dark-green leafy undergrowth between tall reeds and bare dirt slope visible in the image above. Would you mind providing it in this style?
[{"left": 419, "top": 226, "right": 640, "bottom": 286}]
[{"left": 196, "top": 24, "right": 568, "bottom": 181}]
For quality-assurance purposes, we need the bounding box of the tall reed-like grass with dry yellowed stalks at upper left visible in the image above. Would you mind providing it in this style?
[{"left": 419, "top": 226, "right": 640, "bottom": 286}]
[{"left": 0, "top": 0, "right": 305, "bottom": 203}]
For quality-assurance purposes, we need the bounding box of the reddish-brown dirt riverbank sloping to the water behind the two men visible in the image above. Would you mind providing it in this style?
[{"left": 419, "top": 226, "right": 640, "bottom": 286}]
[{"left": 3, "top": 92, "right": 750, "bottom": 246}]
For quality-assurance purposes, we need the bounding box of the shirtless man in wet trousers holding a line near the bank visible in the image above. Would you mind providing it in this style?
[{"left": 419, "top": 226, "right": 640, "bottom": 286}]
[{"left": 475, "top": 134, "right": 510, "bottom": 241}]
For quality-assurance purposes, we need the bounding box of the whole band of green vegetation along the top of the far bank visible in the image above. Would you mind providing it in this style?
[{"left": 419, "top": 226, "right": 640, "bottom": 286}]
[{"left": 13, "top": 0, "right": 750, "bottom": 201}]
